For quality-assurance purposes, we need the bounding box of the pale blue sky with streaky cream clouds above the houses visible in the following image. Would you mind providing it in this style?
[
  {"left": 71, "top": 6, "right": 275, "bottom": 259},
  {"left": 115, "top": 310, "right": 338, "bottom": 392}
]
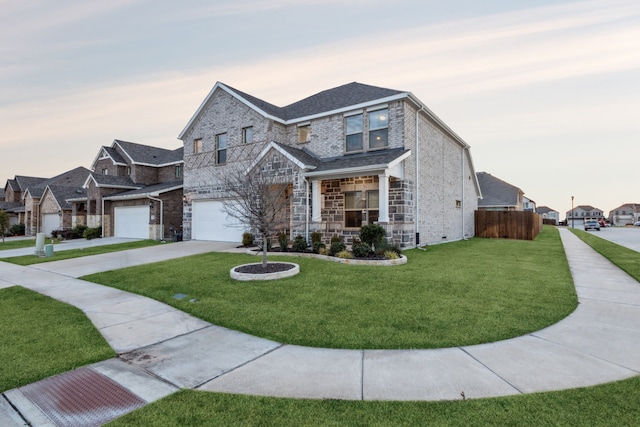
[{"left": 0, "top": 0, "right": 640, "bottom": 218}]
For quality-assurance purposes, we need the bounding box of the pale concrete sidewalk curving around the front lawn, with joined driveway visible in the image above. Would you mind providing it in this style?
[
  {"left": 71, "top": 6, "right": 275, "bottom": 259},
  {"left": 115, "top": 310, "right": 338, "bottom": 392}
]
[{"left": 0, "top": 229, "right": 640, "bottom": 425}]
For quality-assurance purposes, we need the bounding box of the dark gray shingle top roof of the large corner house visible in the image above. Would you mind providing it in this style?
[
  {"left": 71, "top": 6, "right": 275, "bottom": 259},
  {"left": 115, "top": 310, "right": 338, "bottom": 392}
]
[{"left": 225, "top": 82, "right": 407, "bottom": 120}]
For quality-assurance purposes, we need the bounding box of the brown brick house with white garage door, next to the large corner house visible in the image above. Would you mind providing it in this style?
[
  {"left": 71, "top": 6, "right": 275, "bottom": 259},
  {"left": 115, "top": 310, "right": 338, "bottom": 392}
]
[{"left": 76, "top": 140, "right": 184, "bottom": 240}]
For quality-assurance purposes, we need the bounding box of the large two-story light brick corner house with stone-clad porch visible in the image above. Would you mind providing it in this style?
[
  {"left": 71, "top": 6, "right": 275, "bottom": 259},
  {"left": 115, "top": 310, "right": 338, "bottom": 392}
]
[{"left": 179, "top": 82, "right": 480, "bottom": 247}]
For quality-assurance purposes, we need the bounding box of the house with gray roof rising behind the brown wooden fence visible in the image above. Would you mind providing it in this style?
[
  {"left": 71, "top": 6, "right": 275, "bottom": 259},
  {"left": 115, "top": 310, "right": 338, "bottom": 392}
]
[{"left": 476, "top": 172, "right": 524, "bottom": 211}]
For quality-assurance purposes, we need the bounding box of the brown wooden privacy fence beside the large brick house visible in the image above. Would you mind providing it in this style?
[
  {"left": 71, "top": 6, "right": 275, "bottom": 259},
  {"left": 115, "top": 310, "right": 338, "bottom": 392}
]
[{"left": 475, "top": 210, "right": 542, "bottom": 240}]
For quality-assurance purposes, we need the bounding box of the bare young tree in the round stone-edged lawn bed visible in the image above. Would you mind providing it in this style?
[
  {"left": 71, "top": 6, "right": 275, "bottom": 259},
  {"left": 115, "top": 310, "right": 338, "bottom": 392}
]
[{"left": 219, "top": 165, "right": 290, "bottom": 268}]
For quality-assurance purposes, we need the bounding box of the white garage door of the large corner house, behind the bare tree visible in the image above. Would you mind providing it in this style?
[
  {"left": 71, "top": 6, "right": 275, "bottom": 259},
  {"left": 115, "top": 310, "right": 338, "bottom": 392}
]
[{"left": 191, "top": 200, "right": 244, "bottom": 243}]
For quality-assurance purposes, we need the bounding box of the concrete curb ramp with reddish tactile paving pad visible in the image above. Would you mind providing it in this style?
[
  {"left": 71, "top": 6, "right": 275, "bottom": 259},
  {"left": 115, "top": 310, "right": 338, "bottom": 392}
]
[{"left": 20, "top": 367, "right": 146, "bottom": 426}]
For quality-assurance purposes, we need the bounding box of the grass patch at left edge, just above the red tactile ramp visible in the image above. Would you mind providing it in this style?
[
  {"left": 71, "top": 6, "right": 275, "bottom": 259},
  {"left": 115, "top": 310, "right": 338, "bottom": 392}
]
[{"left": 0, "top": 286, "right": 115, "bottom": 391}]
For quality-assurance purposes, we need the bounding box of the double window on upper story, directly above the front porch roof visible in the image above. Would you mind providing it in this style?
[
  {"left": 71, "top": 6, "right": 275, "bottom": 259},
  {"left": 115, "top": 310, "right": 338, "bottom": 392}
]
[{"left": 345, "top": 108, "right": 389, "bottom": 153}]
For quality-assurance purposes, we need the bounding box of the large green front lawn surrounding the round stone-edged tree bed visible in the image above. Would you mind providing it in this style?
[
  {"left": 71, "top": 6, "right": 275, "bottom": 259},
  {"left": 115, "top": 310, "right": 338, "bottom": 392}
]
[{"left": 83, "top": 227, "right": 577, "bottom": 349}]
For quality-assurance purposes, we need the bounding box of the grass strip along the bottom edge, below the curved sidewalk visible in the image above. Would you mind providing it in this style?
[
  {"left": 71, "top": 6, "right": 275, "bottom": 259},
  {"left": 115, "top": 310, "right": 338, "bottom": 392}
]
[{"left": 108, "top": 377, "right": 640, "bottom": 427}]
